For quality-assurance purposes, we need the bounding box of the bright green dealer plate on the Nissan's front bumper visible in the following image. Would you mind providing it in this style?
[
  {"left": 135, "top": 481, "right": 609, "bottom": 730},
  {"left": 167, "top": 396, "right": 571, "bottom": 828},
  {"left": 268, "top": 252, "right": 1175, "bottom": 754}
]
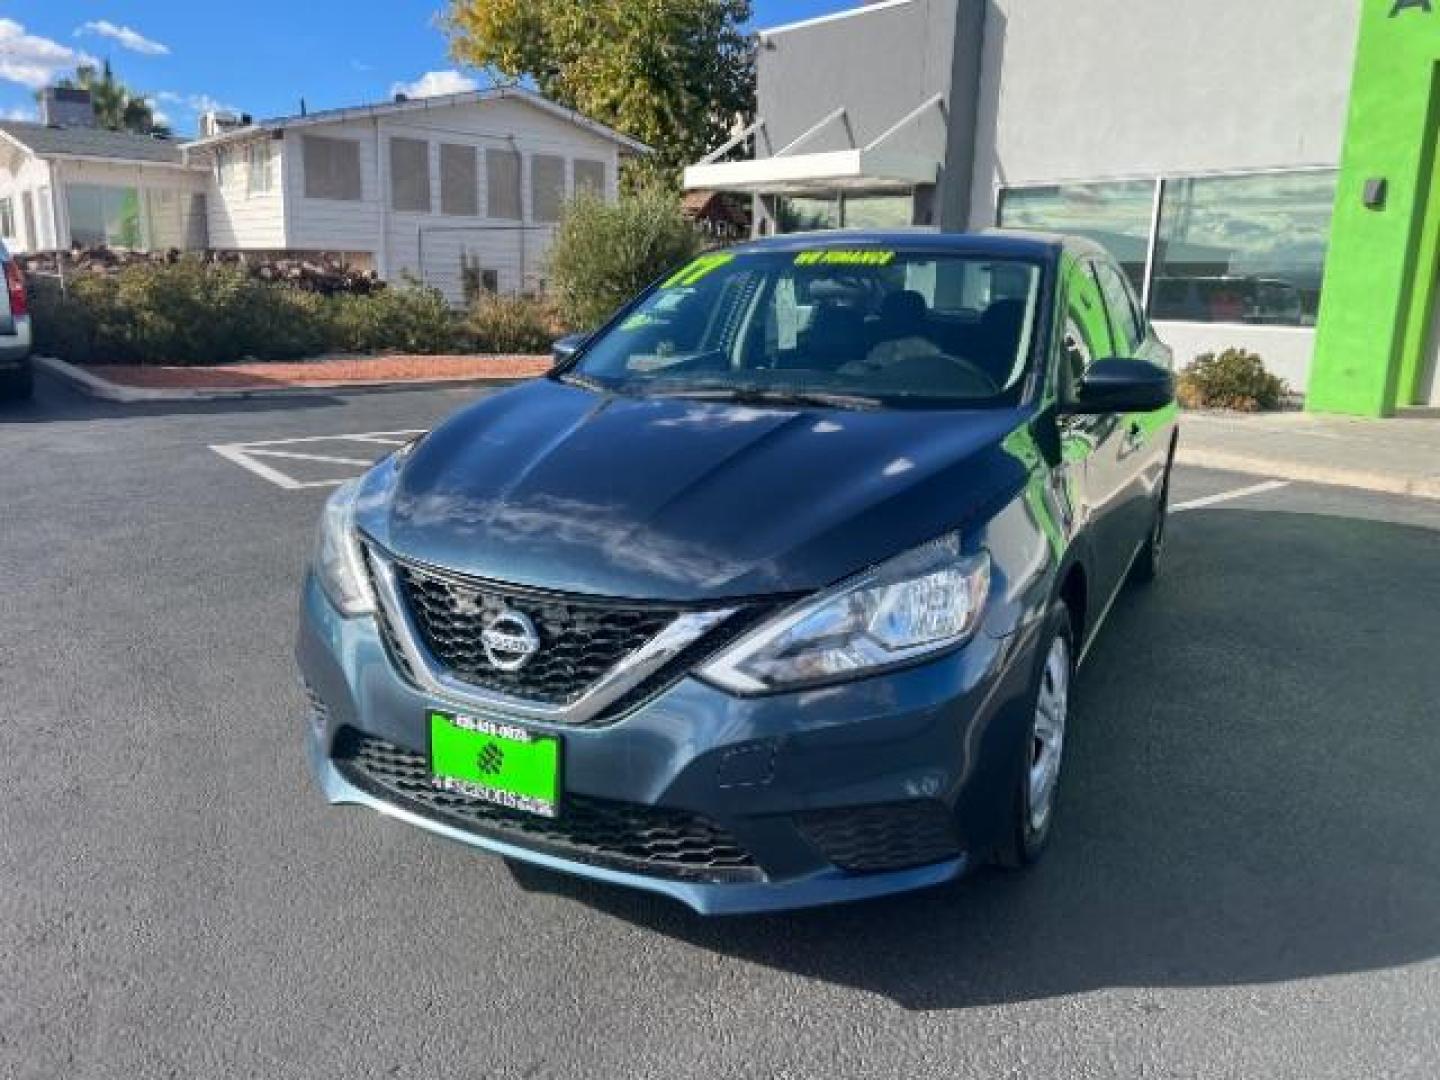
[{"left": 431, "top": 710, "right": 560, "bottom": 818}]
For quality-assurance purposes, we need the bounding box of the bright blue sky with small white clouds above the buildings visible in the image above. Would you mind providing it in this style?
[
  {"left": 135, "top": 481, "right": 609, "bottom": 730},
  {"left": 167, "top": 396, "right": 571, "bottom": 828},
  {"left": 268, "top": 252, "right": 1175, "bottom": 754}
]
[{"left": 0, "top": 0, "right": 858, "bottom": 132}]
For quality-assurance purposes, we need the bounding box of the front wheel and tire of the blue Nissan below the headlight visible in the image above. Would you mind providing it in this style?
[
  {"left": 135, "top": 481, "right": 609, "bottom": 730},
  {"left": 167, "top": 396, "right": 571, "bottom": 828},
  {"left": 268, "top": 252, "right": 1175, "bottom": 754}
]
[{"left": 996, "top": 610, "right": 1076, "bottom": 870}]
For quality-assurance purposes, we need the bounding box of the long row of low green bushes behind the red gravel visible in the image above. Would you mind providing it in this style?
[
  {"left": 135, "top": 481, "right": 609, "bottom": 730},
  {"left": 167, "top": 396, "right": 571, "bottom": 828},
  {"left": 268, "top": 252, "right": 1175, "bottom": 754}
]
[{"left": 30, "top": 258, "right": 461, "bottom": 364}]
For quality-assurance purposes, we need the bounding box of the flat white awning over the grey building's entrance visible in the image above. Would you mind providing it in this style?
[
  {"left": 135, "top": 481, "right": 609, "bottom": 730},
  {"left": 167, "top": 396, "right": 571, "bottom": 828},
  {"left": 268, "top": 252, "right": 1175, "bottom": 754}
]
[{"left": 685, "top": 147, "right": 940, "bottom": 194}]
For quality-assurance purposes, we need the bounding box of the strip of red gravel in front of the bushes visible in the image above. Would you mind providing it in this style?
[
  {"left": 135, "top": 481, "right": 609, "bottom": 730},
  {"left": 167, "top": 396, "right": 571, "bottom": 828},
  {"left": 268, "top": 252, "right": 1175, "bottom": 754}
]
[{"left": 86, "top": 356, "right": 552, "bottom": 390}]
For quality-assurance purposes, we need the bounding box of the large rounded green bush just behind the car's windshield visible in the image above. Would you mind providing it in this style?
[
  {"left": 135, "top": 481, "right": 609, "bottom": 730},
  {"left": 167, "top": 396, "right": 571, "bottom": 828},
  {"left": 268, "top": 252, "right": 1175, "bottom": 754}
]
[{"left": 550, "top": 189, "right": 701, "bottom": 330}]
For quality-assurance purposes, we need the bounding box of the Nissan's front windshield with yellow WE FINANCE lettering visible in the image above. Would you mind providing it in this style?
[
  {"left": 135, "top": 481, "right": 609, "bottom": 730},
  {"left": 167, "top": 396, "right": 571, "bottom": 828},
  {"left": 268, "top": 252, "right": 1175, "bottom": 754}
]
[{"left": 562, "top": 246, "right": 1041, "bottom": 408}]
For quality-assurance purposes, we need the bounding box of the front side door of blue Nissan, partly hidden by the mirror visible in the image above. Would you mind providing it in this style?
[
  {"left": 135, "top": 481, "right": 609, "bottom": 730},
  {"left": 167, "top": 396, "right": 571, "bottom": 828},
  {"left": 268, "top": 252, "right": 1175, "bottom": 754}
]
[{"left": 1057, "top": 256, "right": 1135, "bottom": 605}]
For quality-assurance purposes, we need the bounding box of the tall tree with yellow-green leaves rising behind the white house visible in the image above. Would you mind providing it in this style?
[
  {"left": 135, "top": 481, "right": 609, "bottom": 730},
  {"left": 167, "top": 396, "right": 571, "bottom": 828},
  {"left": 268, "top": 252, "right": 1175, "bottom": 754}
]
[{"left": 445, "top": 0, "right": 755, "bottom": 179}]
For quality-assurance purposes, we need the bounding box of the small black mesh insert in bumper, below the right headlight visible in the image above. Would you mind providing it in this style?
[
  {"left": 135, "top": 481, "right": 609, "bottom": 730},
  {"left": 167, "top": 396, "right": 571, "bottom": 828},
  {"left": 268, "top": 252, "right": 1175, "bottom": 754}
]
[{"left": 795, "top": 799, "right": 960, "bottom": 873}]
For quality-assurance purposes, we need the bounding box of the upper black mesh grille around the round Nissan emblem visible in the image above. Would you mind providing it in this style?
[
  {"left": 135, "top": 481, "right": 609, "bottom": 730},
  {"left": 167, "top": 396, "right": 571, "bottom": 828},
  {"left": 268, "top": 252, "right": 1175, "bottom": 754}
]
[{"left": 392, "top": 562, "right": 680, "bottom": 706}]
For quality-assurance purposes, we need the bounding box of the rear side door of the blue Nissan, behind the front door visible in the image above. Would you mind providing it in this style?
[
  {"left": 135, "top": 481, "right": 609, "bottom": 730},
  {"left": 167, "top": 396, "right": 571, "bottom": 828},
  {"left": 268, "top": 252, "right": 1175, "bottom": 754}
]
[{"left": 1092, "top": 258, "right": 1174, "bottom": 549}]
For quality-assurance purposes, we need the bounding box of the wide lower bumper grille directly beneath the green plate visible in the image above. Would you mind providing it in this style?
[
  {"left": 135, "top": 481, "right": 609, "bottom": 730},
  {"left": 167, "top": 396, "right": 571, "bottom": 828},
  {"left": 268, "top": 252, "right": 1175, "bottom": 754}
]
[{"left": 336, "top": 729, "right": 763, "bottom": 883}]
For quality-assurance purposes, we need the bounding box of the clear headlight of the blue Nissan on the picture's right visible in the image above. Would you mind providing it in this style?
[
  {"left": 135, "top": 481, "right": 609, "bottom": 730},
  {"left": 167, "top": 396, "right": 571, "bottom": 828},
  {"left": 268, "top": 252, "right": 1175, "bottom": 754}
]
[{"left": 700, "top": 533, "right": 991, "bottom": 694}]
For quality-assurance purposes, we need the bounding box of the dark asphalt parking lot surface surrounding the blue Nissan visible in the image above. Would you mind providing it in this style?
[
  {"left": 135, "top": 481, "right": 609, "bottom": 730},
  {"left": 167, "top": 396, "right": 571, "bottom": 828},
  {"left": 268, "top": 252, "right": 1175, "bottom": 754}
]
[{"left": 0, "top": 383, "right": 1440, "bottom": 1080}]
